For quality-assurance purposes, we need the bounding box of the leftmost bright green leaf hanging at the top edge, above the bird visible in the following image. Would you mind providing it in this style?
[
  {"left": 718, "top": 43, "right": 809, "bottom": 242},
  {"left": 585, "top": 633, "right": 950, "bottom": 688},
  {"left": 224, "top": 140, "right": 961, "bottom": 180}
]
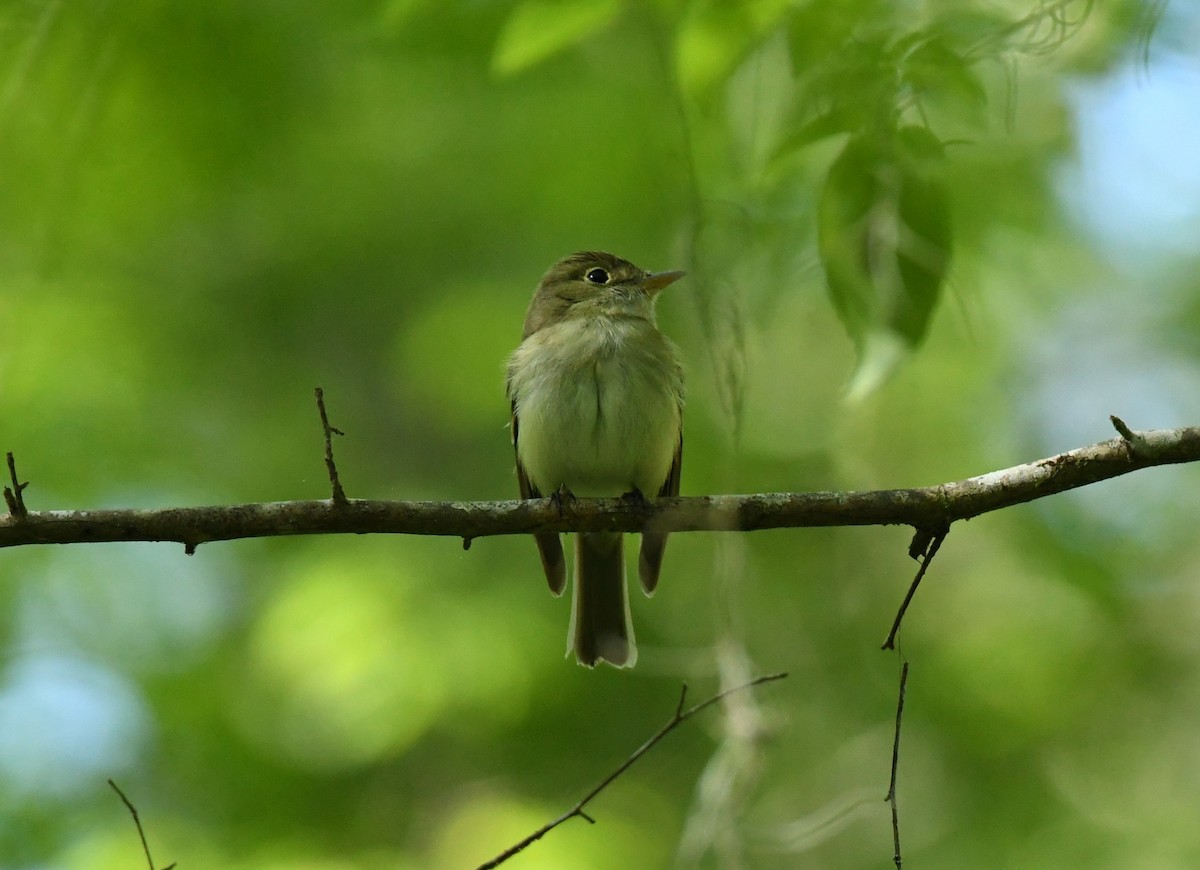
[{"left": 492, "top": 0, "right": 620, "bottom": 76}]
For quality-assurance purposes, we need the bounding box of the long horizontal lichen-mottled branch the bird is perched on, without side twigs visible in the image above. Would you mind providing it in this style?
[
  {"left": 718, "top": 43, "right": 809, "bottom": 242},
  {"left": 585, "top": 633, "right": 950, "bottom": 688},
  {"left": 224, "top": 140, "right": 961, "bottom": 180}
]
[{"left": 0, "top": 422, "right": 1200, "bottom": 551}]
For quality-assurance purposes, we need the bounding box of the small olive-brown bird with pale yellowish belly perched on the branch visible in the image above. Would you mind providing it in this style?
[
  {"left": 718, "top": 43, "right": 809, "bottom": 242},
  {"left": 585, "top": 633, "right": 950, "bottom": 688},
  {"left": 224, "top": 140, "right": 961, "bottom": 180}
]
[{"left": 508, "top": 251, "right": 684, "bottom": 667}]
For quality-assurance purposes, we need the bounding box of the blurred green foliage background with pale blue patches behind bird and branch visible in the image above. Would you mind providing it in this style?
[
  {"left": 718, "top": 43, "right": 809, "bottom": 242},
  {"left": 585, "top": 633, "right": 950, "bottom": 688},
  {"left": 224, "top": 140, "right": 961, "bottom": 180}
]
[{"left": 0, "top": 0, "right": 1200, "bottom": 870}]
